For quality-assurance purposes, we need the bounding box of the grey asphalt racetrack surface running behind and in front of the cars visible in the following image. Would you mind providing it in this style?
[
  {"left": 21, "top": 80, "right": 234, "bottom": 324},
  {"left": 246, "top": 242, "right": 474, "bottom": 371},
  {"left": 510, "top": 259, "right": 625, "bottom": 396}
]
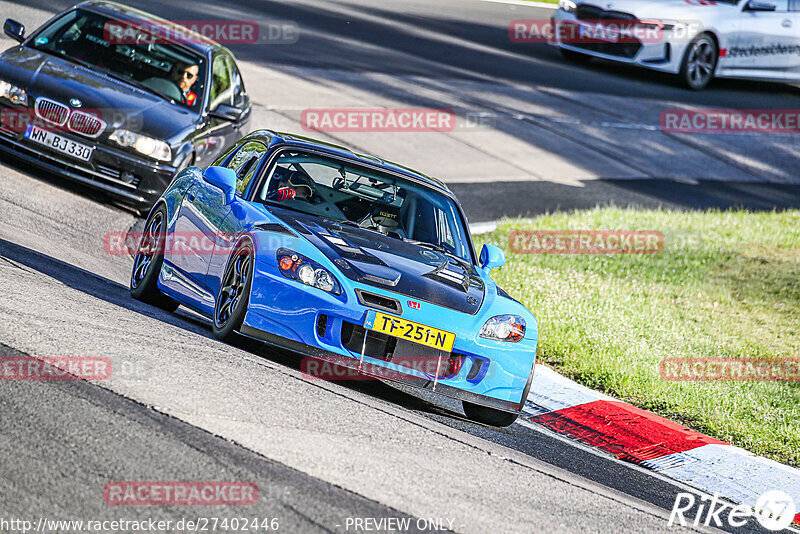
[{"left": 0, "top": 0, "right": 800, "bottom": 532}]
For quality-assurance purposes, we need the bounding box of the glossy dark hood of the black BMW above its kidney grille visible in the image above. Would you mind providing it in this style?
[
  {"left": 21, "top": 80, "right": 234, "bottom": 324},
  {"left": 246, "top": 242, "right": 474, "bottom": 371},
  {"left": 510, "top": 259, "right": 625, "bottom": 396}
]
[{"left": 0, "top": 46, "right": 197, "bottom": 141}]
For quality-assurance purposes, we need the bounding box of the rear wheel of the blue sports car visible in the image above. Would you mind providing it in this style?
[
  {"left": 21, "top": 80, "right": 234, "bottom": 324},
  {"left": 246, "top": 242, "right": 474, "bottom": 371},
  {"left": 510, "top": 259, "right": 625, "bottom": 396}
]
[{"left": 130, "top": 204, "right": 179, "bottom": 312}]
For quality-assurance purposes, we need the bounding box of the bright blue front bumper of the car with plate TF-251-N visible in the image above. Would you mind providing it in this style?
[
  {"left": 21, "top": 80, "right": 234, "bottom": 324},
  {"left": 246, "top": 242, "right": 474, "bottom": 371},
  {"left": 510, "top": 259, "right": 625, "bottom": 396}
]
[{"left": 241, "top": 261, "right": 537, "bottom": 413}]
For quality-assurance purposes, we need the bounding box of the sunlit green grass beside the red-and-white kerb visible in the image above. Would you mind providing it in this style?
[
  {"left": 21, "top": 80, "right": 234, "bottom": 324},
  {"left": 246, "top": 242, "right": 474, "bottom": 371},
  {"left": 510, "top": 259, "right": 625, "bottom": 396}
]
[{"left": 476, "top": 208, "right": 800, "bottom": 466}]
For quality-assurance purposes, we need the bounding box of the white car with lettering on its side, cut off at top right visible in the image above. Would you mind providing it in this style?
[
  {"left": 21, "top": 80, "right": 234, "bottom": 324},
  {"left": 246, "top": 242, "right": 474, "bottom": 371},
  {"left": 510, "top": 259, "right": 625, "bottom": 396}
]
[{"left": 550, "top": 0, "right": 800, "bottom": 90}]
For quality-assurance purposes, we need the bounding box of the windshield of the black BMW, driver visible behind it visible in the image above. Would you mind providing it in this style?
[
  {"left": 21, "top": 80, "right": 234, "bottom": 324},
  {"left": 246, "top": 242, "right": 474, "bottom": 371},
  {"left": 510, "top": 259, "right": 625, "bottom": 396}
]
[{"left": 30, "top": 9, "right": 206, "bottom": 109}]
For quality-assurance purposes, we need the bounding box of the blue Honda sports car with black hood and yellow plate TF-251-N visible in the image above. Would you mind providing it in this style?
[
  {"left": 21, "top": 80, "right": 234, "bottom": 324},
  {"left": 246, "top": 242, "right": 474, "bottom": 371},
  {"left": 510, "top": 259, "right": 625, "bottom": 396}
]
[{"left": 131, "top": 130, "right": 537, "bottom": 426}]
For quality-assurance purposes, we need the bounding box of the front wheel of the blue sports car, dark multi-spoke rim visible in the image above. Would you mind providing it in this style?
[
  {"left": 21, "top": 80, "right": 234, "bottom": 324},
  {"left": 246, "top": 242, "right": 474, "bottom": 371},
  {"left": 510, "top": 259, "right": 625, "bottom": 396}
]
[{"left": 212, "top": 240, "right": 255, "bottom": 341}]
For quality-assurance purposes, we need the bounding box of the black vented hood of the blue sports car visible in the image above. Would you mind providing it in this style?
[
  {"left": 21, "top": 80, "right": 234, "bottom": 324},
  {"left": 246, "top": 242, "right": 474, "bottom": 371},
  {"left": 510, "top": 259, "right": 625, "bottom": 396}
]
[{"left": 270, "top": 208, "right": 484, "bottom": 315}]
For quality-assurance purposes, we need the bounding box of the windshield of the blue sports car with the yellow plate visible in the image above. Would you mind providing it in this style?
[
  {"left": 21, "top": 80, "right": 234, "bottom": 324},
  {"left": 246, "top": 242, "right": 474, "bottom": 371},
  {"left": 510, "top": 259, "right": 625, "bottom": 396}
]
[{"left": 256, "top": 150, "right": 474, "bottom": 264}]
